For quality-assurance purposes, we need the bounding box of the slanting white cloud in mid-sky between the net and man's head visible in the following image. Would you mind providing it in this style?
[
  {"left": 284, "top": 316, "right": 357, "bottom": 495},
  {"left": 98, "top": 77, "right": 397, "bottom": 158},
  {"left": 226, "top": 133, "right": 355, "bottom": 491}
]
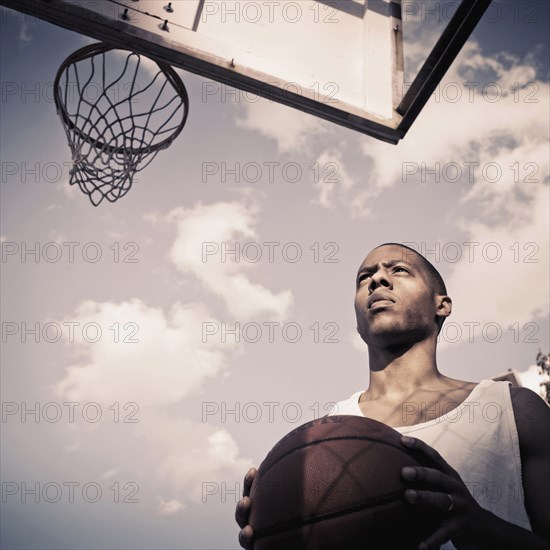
[{"left": 168, "top": 202, "right": 293, "bottom": 320}]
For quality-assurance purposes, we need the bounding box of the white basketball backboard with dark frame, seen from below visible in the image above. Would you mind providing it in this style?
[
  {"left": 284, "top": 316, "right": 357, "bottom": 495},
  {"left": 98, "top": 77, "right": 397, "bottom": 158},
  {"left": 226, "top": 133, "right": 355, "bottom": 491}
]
[{"left": 0, "top": 0, "right": 490, "bottom": 143}]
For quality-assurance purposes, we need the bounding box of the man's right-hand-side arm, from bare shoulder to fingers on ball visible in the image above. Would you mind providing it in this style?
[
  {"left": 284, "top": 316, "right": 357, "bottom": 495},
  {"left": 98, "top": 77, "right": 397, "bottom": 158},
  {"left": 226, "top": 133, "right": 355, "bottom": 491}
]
[{"left": 402, "top": 388, "right": 550, "bottom": 550}]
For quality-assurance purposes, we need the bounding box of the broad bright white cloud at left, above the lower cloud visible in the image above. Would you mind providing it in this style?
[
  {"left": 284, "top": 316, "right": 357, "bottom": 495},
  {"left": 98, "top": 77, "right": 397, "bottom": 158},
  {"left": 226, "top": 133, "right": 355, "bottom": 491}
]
[{"left": 55, "top": 299, "right": 235, "bottom": 407}]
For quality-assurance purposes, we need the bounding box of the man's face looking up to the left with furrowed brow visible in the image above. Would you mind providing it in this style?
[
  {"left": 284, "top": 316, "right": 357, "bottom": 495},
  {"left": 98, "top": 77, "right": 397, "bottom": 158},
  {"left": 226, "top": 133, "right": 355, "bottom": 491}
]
[{"left": 355, "top": 245, "right": 444, "bottom": 345}]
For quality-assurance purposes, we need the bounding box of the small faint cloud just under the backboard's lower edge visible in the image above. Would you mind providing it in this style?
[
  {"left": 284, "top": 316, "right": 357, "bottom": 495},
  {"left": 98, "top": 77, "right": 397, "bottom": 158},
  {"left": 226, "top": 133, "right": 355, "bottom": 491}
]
[{"left": 236, "top": 99, "right": 328, "bottom": 153}]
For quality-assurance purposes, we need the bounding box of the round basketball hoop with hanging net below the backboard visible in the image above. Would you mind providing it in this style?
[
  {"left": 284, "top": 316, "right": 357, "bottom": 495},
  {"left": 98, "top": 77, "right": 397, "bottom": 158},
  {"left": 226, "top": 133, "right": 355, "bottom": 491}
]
[{"left": 54, "top": 43, "right": 189, "bottom": 206}]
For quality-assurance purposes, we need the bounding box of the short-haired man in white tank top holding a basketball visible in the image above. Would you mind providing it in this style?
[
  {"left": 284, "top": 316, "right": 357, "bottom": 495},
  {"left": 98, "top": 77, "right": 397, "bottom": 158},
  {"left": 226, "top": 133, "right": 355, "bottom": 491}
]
[{"left": 236, "top": 243, "right": 550, "bottom": 550}]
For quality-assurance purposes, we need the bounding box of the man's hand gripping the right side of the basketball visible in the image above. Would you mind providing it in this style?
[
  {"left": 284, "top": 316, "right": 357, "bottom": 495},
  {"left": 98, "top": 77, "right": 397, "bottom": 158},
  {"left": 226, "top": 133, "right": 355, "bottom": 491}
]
[{"left": 401, "top": 436, "right": 499, "bottom": 550}]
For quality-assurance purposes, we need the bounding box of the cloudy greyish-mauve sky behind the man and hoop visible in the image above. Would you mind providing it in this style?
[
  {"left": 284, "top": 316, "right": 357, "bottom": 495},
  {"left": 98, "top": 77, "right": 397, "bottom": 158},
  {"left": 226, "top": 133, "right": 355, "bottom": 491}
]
[{"left": 0, "top": 0, "right": 550, "bottom": 550}]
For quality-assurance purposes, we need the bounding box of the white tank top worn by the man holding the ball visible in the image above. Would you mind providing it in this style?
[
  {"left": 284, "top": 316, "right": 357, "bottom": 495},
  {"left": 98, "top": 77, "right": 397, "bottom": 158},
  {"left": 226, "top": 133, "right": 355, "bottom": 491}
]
[{"left": 329, "top": 380, "right": 532, "bottom": 550}]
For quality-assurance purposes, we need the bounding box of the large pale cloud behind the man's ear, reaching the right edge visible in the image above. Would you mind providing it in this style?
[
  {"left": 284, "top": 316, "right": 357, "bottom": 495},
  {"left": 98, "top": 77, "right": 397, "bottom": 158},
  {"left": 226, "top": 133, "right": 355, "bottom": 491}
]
[{"left": 446, "top": 185, "right": 550, "bottom": 338}]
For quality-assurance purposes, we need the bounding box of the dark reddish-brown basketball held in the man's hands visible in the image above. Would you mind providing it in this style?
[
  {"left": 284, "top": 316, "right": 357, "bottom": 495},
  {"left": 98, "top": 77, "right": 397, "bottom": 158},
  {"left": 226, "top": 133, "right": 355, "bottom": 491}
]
[{"left": 250, "top": 416, "right": 448, "bottom": 550}]
